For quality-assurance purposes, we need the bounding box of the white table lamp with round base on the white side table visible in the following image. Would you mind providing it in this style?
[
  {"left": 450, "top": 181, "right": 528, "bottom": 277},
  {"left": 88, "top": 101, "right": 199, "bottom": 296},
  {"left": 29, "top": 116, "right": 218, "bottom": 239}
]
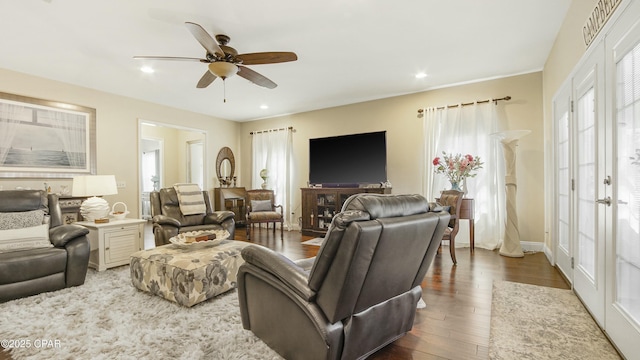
[{"left": 71, "top": 175, "right": 118, "bottom": 222}]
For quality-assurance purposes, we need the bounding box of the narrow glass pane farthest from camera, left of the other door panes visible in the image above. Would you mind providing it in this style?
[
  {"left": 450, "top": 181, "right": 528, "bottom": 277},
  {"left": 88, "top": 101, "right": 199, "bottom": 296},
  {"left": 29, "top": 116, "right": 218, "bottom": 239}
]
[{"left": 557, "top": 110, "right": 571, "bottom": 253}]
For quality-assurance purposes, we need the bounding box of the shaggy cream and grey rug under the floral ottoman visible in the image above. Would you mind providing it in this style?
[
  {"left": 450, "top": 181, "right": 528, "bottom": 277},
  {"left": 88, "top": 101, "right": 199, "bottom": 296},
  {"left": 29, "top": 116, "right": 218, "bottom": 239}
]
[{"left": 0, "top": 266, "right": 281, "bottom": 360}]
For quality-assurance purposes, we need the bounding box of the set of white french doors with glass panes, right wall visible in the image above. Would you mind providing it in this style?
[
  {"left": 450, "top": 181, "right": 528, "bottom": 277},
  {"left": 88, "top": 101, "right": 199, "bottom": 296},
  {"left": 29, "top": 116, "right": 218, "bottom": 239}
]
[{"left": 553, "top": 0, "right": 640, "bottom": 358}]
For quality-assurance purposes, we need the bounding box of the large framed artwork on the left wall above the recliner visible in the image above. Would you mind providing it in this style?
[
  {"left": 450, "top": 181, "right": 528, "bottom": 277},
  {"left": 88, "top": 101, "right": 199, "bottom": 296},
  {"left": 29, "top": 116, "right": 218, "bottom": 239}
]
[{"left": 0, "top": 92, "right": 96, "bottom": 178}]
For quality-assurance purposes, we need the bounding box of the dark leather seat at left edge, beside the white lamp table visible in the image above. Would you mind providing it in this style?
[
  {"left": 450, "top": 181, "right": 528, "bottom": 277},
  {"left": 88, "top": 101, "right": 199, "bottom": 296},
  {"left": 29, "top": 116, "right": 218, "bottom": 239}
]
[{"left": 0, "top": 190, "right": 91, "bottom": 302}]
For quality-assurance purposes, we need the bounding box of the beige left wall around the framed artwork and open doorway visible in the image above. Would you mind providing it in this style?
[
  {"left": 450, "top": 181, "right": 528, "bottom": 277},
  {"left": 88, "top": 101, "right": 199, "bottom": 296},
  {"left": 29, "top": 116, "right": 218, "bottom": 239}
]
[{"left": 0, "top": 69, "right": 240, "bottom": 216}]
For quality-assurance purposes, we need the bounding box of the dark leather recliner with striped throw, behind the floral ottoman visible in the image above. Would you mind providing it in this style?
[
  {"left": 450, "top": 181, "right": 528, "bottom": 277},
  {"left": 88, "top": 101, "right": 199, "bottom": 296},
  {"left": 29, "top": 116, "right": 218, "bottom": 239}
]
[{"left": 150, "top": 188, "right": 236, "bottom": 246}]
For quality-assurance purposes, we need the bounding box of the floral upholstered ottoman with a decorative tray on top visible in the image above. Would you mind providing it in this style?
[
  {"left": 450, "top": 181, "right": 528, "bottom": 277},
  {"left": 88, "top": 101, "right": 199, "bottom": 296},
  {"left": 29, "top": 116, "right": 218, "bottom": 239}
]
[{"left": 130, "top": 240, "right": 249, "bottom": 307}]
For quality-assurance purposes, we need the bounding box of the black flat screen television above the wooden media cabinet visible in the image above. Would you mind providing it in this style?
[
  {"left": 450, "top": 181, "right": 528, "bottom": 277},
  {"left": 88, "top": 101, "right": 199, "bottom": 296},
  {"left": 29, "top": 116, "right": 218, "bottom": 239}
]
[{"left": 309, "top": 131, "right": 387, "bottom": 187}]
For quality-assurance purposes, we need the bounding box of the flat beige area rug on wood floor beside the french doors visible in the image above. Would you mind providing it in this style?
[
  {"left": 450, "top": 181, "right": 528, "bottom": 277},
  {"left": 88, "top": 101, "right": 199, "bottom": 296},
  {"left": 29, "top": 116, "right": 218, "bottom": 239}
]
[{"left": 489, "top": 281, "right": 620, "bottom": 360}]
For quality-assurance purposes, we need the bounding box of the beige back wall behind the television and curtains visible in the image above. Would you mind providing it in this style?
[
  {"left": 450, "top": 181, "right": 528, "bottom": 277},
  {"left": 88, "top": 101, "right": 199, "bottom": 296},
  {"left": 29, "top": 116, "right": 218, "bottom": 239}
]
[{"left": 240, "top": 72, "right": 544, "bottom": 242}]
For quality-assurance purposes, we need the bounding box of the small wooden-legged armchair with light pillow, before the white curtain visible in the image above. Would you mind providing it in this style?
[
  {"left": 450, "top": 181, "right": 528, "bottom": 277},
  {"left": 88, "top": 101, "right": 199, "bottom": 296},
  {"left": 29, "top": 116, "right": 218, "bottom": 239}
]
[{"left": 246, "top": 189, "right": 284, "bottom": 240}]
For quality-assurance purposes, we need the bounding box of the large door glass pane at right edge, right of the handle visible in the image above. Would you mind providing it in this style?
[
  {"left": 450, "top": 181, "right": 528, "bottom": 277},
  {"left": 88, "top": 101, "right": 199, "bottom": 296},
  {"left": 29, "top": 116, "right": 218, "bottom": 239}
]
[{"left": 616, "top": 40, "right": 640, "bottom": 324}]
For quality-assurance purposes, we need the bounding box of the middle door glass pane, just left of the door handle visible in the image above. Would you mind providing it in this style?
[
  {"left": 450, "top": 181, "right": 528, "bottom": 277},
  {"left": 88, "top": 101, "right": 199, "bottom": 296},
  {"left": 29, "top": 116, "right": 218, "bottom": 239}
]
[{"left": 576, "top": 88, "right": 597, "bottom": 280}]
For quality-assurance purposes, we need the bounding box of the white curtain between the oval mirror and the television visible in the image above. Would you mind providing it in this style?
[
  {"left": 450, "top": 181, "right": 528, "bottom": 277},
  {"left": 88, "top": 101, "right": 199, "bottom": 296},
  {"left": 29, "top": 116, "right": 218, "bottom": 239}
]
[{"left": 251, "top": 129, "right": 294, "bottom": 230}]
